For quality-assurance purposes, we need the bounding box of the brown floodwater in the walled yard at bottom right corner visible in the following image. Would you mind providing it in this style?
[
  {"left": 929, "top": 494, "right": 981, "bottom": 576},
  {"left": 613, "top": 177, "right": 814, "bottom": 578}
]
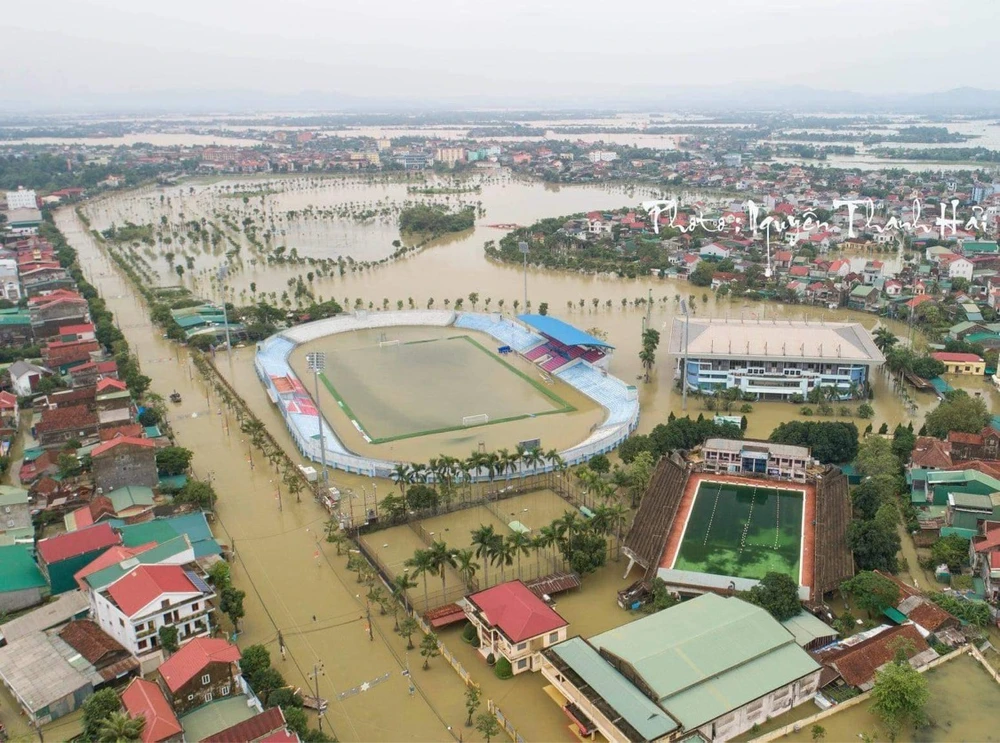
[{"left": 779, "top": 655, "right": 1000, "bottom": 743}]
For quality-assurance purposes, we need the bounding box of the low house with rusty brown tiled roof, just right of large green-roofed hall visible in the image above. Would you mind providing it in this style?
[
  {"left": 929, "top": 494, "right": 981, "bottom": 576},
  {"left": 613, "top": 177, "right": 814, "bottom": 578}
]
[{"left": 813, "top": 624, "right": 938, "bottom": 691}]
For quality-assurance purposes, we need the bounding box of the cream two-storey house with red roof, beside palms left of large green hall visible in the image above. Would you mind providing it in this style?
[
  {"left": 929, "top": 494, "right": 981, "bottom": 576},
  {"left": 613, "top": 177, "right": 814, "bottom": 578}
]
[{"left": 464, "top": 580, "right": 568, "bottom": 675}]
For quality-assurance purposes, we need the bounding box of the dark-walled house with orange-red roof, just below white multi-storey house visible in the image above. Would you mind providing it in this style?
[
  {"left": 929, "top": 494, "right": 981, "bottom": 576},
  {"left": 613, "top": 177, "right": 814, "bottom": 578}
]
[{"left": 157, "top": 637, "right": 244, "bottom": 715}]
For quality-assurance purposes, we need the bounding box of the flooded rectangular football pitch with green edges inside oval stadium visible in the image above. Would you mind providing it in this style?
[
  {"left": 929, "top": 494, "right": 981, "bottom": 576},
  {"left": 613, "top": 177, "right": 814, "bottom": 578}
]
[{"left": 320, "top": 335, "right": 576, "bottom": 444}]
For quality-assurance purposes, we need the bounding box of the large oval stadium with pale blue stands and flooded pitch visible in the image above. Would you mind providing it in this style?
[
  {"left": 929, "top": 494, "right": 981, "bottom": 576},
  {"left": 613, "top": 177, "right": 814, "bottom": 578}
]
[{"left": 254, "top": 310, "right": 639, "bottom": 479}]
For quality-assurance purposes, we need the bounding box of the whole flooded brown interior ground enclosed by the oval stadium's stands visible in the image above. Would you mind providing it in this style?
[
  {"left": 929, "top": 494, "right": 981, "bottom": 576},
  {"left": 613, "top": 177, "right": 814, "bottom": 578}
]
[{"left": 290, "top": 327, "right": 605, "bottom": 462}]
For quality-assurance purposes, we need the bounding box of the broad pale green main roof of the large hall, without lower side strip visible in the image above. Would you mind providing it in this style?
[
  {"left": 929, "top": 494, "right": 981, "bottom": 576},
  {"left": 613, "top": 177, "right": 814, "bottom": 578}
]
[{"left": 591, "top": 593, "right": 819, "bottom": 730}]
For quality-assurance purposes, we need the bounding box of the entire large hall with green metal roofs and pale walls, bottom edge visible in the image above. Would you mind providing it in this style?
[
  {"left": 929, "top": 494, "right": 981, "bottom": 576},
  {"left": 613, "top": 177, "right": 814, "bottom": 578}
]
[{"left": 541, "top": 593, "right": 820, "bottom": 743}]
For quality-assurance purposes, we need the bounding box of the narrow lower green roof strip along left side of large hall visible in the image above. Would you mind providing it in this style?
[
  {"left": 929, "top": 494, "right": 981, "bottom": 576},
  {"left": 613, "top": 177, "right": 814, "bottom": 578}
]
[{"left": 552, "top": 637, "right": 677, "bottom": 740}]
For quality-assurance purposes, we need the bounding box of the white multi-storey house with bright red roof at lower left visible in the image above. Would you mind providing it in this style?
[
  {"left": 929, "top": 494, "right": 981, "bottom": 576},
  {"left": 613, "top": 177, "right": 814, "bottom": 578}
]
[{"left": 92, "top": 560, "right": 215, "bottom": 656}]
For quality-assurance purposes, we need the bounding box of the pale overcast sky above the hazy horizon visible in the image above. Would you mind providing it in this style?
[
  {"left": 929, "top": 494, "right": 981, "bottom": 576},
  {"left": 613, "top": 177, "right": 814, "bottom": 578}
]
[{"left": 0, "top": 0, "right": 1000, "bottom": 112}]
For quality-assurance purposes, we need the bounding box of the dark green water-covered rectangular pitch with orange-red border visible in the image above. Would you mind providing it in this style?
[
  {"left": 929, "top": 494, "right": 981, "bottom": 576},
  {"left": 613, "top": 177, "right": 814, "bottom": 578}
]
[{"left": 673, "top": 480, "right": 805, "bottom": 583}]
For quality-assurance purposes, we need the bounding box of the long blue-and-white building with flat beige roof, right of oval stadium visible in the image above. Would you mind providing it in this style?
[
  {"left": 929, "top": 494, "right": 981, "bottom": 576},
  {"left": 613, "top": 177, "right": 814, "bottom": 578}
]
[{"left": 668, "top": 318, "right": 885, "bottom": 400}]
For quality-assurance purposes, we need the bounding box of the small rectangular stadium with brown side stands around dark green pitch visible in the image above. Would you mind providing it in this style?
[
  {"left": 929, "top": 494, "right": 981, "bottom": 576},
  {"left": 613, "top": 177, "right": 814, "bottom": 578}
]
[{"left": 623, "top": 439, "right": 854, "bottom": 602}]
